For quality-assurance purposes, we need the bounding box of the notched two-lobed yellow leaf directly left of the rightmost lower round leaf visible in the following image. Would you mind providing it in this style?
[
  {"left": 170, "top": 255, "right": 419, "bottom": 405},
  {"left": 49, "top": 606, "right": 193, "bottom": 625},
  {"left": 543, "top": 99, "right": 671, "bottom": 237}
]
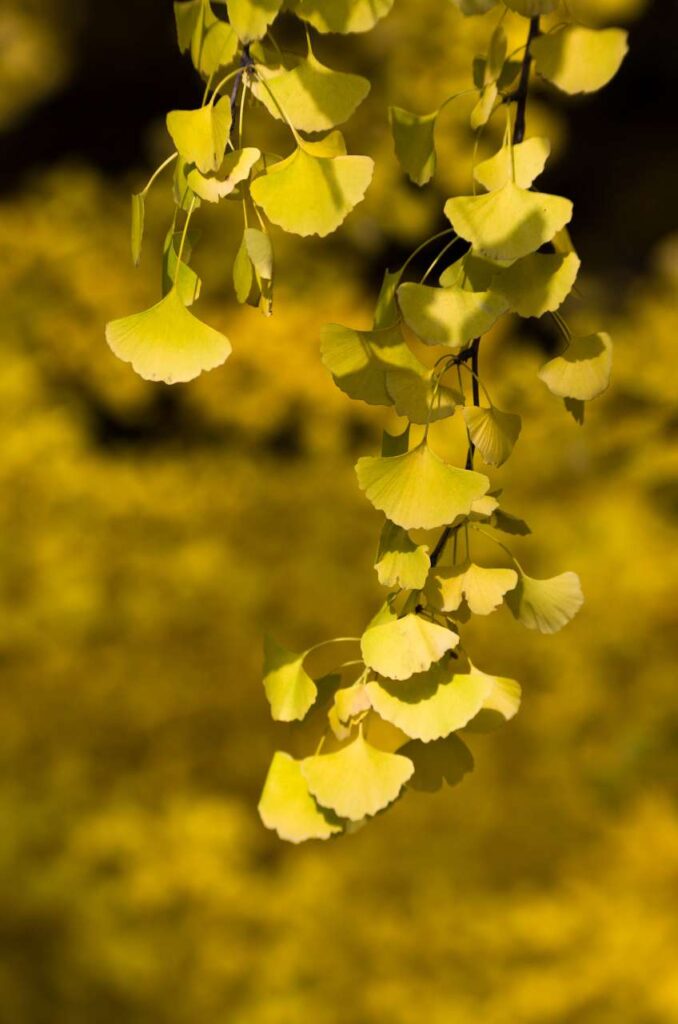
[{"left": 425, "top": 562, "right": 518, "bottom": 615}]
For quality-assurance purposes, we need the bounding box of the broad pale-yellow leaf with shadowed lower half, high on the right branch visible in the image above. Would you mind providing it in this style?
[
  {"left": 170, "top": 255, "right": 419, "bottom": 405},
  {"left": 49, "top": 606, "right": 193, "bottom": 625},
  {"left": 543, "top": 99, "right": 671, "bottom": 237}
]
[{"left": 444, "top": 181, "right": 573, "bottom": 259}]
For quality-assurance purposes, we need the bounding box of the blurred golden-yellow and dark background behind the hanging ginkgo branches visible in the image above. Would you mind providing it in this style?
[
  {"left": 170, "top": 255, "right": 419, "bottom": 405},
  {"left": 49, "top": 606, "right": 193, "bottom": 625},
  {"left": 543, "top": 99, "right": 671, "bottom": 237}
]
[{"left": 0, "top": 0, "right": 678, "bottom": 1024}]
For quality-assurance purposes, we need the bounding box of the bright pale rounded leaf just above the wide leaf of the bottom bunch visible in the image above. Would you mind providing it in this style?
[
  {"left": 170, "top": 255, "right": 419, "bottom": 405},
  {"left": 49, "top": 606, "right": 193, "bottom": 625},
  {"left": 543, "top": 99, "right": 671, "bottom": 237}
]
[{"left": 361, "top": 612, "right": 459, "bottom": 679}]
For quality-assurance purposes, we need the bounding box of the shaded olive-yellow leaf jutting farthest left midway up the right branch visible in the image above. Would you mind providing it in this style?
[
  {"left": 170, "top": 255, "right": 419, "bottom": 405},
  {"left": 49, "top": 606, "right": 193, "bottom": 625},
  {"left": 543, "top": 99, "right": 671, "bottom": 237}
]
[{"left": 321, "top": 324, "right": 423, "bottom": 406}]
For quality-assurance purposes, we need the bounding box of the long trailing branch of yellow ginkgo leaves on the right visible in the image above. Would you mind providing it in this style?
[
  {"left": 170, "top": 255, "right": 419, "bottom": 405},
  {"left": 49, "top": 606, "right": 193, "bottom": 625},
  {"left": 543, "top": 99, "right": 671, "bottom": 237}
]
[{"left": 259, "top": 0, "right": 626, "bottom": 842}]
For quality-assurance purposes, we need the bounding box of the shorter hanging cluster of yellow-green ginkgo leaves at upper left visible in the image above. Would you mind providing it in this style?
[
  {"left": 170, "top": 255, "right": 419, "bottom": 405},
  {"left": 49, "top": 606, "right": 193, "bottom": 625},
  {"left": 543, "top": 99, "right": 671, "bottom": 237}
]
[{"left": 107, "top": 0, "right": 393, "bottom": 384}]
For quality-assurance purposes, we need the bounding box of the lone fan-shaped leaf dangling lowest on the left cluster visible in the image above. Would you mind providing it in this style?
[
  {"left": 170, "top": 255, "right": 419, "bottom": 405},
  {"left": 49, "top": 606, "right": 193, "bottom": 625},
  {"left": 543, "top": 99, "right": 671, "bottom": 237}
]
[{"left": 105, "top": 288, "right": 230, "bottom": 384}]
